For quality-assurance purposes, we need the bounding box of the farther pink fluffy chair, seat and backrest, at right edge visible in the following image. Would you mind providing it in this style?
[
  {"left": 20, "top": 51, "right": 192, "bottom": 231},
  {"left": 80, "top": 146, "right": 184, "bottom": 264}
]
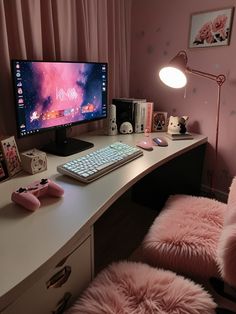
[{"left": 142, "top": 178, "right": 236, "bottom": 313}]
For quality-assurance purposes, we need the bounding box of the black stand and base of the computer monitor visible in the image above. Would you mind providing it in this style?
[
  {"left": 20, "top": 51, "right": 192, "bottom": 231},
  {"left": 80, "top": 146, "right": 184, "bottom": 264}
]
[{"left": 42, "top": 129, "right": 94, "bottom": 156}]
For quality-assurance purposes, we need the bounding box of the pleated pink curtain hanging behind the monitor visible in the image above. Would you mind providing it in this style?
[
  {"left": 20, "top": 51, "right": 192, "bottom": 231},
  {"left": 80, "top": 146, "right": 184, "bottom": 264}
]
[{"left": 0, "top": 0, "right": 132, "bottom": 146}]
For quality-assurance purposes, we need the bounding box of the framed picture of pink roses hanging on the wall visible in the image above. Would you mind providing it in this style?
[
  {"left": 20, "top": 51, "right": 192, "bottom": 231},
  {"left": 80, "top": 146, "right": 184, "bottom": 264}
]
[{"left": 189, "top": 7, "right": 234, "bottom": 48}]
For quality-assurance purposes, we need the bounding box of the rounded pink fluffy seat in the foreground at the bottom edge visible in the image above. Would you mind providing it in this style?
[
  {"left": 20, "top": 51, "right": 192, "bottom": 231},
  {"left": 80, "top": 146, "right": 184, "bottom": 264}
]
[{"left": 65, "top": 262, "right": 216, "bottom": 314}]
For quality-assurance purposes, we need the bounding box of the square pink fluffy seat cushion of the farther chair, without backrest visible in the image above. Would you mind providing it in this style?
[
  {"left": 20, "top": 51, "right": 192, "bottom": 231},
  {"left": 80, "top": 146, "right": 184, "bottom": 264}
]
[{"left": 142, "top": 195, "right": 226, "bottom": 278}]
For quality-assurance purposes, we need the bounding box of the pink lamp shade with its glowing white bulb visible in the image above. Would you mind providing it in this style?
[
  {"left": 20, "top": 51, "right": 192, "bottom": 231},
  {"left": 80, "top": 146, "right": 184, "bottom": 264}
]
[{"left": 159, "top": 51, "right": 188, "bottom": 88}]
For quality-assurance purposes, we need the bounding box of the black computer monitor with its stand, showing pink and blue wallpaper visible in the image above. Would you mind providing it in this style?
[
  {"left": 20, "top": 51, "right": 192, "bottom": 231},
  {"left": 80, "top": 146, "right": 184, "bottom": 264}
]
[{"left": 11, "top": 60, "right": 108, "bottom": 156}]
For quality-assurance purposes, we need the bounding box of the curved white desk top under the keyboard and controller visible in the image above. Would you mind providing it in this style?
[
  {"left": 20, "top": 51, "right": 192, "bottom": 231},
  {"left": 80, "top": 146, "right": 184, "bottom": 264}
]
[{"left": 0, "top": 133, "right": 207, "bottom": 311}]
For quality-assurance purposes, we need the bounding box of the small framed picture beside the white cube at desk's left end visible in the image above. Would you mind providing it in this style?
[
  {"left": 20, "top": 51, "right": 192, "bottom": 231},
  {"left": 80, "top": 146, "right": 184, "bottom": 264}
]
[{"left": 1, "top": 136, "right": 22, "bottom": 176}]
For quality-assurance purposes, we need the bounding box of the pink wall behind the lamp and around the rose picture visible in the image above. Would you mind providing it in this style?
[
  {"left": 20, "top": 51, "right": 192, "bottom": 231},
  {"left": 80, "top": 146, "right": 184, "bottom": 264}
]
[{"left": 130, "top": 0, "right": 236, "bottom": 193}]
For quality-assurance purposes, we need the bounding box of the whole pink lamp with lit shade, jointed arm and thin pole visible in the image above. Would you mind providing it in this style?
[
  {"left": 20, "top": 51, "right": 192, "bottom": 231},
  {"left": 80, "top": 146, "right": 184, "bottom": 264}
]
[{"left": 159, "top": 50, "right": 226, "bottom": 189}]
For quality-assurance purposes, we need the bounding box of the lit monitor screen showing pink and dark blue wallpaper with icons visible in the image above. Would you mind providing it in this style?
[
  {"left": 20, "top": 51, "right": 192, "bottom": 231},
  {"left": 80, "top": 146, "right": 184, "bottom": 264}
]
[{"left": 16, "top": 62, "right": 106, "bottom": 134}]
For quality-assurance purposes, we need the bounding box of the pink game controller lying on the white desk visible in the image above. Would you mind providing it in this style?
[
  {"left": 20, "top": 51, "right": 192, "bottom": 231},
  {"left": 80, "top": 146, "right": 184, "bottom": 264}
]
[{"left": 11, "top": 179, "right": 64, "bottom": 211}]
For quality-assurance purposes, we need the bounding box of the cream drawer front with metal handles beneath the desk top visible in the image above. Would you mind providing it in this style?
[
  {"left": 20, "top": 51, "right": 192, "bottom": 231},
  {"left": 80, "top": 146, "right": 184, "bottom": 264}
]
[{"left": 1, "top": 236, "right": 92, "bottom": 314}]
